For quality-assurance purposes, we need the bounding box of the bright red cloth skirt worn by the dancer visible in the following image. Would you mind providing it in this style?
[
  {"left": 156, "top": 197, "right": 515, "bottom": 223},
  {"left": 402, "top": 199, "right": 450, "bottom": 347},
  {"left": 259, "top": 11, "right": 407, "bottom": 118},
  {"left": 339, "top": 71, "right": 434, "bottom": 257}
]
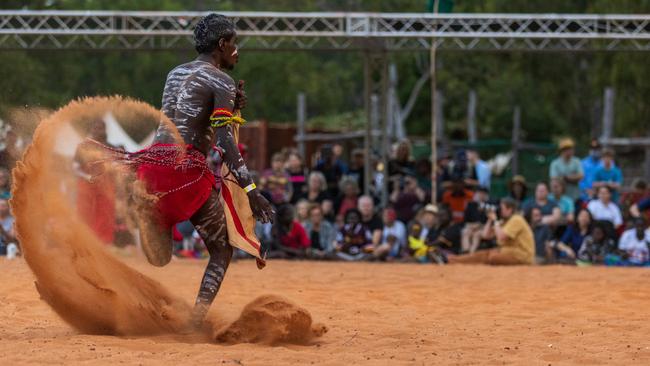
[{"left": 134, "top": 144, "right": 217, "bottom": 228}]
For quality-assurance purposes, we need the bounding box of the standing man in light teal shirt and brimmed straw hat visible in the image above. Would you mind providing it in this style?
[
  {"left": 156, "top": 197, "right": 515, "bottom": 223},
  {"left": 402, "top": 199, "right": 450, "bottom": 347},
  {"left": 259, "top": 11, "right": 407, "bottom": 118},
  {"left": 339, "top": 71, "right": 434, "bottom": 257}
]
[{"left": 549, "top": 138, "right": 584, "bottom": 201}]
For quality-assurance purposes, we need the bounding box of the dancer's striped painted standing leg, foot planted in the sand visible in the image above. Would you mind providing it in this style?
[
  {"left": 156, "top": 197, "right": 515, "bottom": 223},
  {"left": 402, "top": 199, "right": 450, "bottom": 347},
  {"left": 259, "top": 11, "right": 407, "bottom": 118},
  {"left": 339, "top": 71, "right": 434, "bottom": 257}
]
[{"left": 190, "top": 190, "right": 233, "bottom": 327}]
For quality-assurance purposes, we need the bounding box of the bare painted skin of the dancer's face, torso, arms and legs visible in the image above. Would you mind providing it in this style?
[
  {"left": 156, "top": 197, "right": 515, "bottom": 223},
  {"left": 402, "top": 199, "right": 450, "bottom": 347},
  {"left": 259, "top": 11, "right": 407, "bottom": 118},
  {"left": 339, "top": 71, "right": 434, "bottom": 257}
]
[{"left": 134, "top": 30, "right": 275, "bottom": 327}]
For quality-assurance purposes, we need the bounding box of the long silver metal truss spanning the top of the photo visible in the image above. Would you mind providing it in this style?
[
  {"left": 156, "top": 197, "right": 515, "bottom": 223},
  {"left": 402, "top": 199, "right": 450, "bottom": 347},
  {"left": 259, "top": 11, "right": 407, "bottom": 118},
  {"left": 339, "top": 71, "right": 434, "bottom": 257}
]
[{"left": 0, "top": 10, "right": 650, "bottom": 51}]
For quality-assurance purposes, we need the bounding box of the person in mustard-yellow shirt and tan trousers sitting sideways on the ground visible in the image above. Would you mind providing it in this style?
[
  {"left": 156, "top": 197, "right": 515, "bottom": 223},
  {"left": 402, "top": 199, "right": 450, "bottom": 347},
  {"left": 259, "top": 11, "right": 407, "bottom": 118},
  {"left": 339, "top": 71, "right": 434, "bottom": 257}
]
[{"left": 447, "top": 198, "right": 535, "bottom": 265}]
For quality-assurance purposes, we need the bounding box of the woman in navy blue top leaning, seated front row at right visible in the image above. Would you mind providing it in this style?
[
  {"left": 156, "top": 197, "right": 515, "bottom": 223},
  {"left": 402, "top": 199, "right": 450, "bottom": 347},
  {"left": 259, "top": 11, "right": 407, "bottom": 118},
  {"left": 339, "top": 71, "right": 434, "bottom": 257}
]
[{"left": 546, "top": 208, "right": 593, "bottom": 263}]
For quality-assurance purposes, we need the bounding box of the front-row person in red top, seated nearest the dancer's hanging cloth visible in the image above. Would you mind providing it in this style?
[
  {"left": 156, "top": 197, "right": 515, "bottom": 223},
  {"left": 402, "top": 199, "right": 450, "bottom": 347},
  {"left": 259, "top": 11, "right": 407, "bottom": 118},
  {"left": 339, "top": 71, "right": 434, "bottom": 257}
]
[{"left": 260, "top": 204, "right": 311, "bottom": 258}]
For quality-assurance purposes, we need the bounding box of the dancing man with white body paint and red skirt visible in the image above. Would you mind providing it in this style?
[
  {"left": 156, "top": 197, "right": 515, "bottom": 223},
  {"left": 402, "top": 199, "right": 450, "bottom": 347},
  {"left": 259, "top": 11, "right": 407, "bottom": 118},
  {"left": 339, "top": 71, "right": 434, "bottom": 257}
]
[{"left": 133, "top": 14, "right": 274, "bottom": 326}]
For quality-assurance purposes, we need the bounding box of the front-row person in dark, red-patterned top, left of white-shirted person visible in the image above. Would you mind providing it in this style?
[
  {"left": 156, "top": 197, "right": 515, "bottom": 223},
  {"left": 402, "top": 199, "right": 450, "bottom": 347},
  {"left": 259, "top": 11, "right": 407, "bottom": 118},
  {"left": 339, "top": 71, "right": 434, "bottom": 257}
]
[{"left": 336, "top": 208, "right": 372, "bottom": 261}]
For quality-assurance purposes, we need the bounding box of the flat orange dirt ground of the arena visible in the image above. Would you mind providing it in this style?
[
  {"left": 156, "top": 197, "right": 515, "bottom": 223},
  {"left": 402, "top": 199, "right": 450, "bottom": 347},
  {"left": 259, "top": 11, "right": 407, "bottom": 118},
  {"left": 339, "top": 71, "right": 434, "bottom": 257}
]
[{"left": 0, "top": 259, "right": 650, "bottom": 365}]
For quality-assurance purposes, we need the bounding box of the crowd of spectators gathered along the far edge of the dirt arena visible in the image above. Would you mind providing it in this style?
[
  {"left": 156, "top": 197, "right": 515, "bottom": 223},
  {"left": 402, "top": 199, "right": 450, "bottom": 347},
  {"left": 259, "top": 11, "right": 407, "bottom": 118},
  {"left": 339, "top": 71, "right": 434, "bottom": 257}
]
[{"left": 0, "top": 132, "right": 650, "bottom": 266}]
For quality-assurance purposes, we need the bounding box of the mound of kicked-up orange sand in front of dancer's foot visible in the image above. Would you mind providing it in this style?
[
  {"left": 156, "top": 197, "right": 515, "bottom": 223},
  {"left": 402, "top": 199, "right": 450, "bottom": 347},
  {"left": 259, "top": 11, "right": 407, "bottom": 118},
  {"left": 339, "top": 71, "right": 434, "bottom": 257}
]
[{"left": 214, "top": 295, "right": 327, "bottom": 344}]
